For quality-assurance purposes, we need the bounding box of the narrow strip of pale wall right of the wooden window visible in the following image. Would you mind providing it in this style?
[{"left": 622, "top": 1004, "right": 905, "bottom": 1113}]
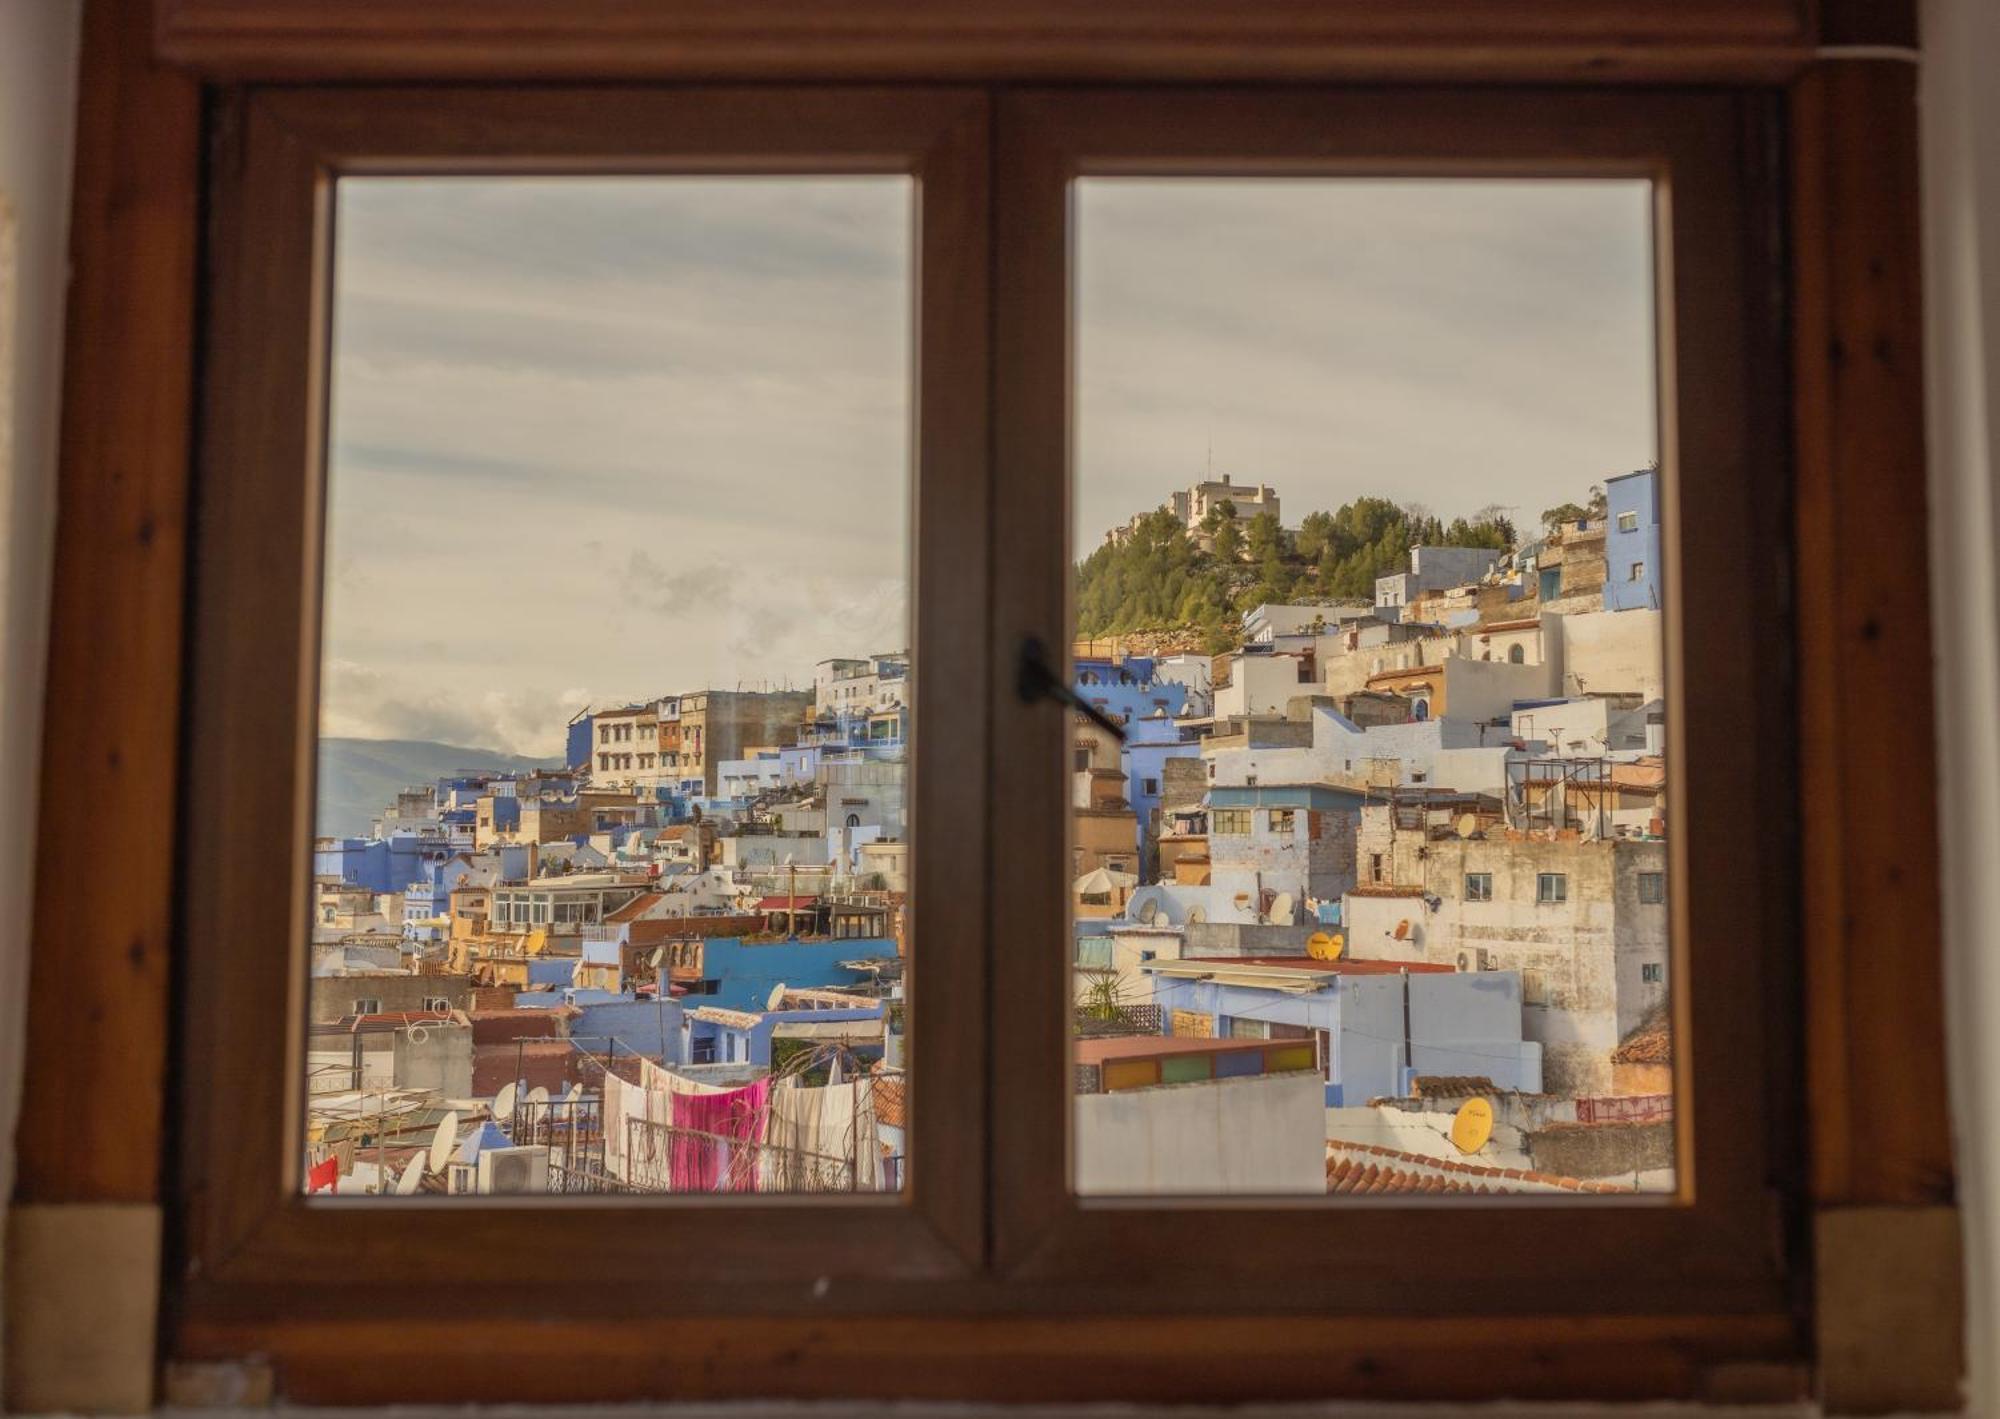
[{"left": 1922, "top": 0, "right": 2000, "bottom": 1415}]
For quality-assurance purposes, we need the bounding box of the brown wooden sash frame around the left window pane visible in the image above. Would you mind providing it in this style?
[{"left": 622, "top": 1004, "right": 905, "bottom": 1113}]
[{"left": 176, "top": 88, "right": 986, "bottom": 1317}]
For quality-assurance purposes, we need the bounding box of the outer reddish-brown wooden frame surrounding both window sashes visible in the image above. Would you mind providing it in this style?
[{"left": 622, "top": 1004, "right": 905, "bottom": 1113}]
[{"left": 6, "top": 0, "right": 1962, "bottom": 1413}]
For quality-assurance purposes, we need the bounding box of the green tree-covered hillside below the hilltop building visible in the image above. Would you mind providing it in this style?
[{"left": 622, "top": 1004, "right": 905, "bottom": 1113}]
[{"left": 1076, "top": 498, "right": 1514, "bottom": 652}]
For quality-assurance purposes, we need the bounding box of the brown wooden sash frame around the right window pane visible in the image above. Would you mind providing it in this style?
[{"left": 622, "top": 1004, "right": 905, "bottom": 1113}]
[{"left": 992, "top": 90, "right": 1798, "bottom": 1319}]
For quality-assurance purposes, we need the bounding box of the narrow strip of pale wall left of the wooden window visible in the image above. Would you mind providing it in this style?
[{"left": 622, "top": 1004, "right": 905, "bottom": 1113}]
[{"left": 0, "top": 0, "right": 82, "bottom": 1231}]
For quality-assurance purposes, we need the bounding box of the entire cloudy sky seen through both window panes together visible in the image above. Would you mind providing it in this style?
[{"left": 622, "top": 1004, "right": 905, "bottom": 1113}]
[{"left": 320, "top": 178, "right": 1656, "bottom": 755}]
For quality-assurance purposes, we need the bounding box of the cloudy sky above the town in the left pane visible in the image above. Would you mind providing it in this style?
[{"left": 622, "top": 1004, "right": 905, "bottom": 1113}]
[{"left": 322, "top": 178, "right": 912, "bottom": 753}]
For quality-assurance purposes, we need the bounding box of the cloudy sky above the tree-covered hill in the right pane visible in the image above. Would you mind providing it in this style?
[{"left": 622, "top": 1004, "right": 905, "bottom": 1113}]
[{"left": 1076, "top": 178, "right": 1658, "bottom": 554}]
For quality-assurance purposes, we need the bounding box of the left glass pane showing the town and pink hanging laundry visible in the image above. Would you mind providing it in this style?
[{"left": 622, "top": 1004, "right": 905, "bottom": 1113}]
[{"left": 302, "top": 176, "right": 914, "bottom": 1197}]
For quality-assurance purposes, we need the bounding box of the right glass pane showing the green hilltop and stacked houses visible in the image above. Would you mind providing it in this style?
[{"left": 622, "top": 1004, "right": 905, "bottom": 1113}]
[{"left": 1068, "top": 178, "right": 1674, "bottom": 1197}]
